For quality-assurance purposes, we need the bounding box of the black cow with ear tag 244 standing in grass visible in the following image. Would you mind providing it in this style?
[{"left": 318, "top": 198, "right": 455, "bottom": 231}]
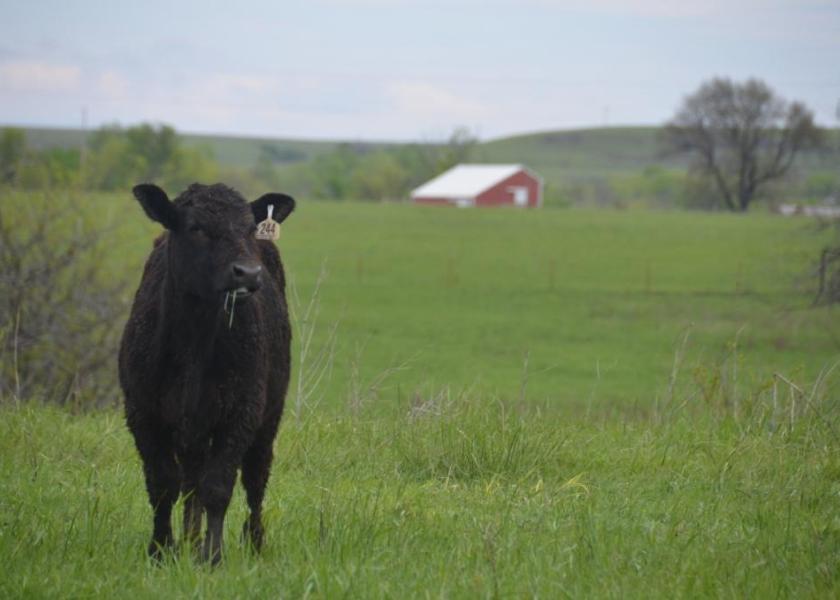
[{"left": 119, "top": 184, "right": 295, "bottom": 563}]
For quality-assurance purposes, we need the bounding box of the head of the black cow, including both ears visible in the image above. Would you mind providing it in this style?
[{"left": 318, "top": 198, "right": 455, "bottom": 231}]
[{"left": 133, "top": 183, "right": 295, "bottom": 301}]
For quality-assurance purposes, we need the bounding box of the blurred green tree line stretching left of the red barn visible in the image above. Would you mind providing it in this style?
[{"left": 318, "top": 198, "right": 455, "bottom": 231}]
[{"left": 0, "top": 123, "right": 476, "bottom": 201}]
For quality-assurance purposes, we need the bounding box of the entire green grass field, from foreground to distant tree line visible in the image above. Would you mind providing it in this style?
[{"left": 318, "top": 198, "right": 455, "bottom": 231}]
[{"left": 0, "top": 194, "right": 840, "bottom": 598}]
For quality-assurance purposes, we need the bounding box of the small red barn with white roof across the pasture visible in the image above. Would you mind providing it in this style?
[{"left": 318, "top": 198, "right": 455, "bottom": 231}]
[{"left": 411, "top": 165, "right": 543, "bottom": 208}]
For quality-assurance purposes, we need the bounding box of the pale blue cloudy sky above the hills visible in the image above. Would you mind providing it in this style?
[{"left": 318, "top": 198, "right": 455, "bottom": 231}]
[{"left": 0, "top": 0, "right": 840, "bottom": 140}]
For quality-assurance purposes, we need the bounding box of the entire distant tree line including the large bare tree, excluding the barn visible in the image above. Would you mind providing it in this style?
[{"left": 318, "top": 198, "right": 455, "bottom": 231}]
[{"left": 0, "top": 78, "right": 840, "bottom": 212}]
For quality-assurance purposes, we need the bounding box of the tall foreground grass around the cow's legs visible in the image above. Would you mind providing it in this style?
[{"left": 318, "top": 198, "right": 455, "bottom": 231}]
[{"left": 0, "top": 372, "right": 840, "bottom": 598}]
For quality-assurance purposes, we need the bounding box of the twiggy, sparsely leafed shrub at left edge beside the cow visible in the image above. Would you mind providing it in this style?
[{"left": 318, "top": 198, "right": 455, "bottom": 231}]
[{"left": 0, "top": 190, "right": 126, "bottom": 406}]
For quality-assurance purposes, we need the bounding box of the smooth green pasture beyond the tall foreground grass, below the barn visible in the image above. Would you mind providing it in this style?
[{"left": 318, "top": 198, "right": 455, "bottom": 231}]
[{"left": 26, "top": 194, "right": 840, "bottom": 413}]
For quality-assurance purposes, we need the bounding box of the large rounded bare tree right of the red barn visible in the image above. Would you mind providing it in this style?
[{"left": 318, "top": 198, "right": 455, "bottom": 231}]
[{"left": 664, "top": 79, "right": 823, "bottom": 212}]
